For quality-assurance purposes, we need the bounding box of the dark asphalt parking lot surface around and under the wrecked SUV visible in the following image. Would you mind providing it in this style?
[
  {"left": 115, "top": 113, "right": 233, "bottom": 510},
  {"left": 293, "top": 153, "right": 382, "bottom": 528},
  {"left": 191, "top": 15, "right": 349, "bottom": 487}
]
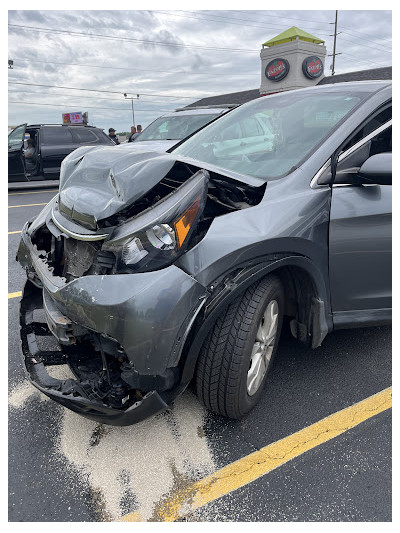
[{"left": 8, "top": 189, "right": 391, "bottom": 522}]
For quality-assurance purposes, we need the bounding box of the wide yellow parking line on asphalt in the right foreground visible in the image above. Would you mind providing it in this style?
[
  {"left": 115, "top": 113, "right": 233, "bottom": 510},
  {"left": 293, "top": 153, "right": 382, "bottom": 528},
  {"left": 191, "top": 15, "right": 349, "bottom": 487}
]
[{"left": 121, "top": 387, "right": 392, "bottom": 522}]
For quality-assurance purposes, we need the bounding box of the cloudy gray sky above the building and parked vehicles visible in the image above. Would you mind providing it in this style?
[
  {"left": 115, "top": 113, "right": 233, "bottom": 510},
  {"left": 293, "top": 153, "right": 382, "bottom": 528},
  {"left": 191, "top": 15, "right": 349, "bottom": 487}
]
[{"left": 8, "top": 6, "right": 392, "bottom": 131}]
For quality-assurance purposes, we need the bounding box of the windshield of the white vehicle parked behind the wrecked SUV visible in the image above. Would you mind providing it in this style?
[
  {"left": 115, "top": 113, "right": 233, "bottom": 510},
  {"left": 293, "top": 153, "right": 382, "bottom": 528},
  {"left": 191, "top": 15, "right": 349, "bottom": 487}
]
[{"left": 135, "top": 114, "right": 217, "bottom": 142}]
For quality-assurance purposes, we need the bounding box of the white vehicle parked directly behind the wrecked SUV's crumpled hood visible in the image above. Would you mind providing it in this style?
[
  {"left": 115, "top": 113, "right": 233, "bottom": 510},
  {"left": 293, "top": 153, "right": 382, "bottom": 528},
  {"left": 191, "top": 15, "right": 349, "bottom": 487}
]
[{"left": 129, "top": 105, "right": 236, "bottom": 152}]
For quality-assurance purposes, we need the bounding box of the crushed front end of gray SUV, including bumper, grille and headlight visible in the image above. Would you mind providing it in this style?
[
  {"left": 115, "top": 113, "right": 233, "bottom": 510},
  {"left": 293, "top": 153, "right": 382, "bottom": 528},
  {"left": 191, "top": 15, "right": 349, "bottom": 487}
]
[{"left": 17, "top": 150, "right": 266, "bottom": 425}]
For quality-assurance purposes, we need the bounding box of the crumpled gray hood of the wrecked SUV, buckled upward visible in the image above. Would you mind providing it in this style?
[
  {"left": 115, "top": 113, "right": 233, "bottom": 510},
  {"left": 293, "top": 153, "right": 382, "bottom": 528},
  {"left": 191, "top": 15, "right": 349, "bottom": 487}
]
[{"left": 60, "top": 145, "right": 176, "bottom": 229}]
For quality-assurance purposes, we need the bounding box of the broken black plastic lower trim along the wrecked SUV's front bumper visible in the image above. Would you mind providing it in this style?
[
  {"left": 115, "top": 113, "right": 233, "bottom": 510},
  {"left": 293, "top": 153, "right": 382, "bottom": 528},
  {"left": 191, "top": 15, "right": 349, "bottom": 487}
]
[{"left": 20, "top": 281, "right": 168, "bottom": 426}]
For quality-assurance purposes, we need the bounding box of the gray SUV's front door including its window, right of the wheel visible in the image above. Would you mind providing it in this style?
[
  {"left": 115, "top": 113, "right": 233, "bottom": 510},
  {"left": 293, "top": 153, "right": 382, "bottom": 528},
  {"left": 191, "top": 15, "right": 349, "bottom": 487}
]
[{"left": 329, "top": 108, "right": 392, "bottom": 327}]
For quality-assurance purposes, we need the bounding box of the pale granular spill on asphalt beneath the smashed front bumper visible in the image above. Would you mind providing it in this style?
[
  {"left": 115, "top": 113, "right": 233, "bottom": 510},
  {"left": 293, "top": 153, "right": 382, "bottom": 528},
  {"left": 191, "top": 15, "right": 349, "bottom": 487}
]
[{"left": 9, "top": 374, "right": 215, "bottom": 520}]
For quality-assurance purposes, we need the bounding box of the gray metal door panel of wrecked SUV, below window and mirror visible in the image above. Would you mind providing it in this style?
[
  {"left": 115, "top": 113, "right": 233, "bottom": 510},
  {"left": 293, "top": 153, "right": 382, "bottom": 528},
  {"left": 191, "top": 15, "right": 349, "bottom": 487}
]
[{"left": 329, "top": 185, "right": 392, "bottom": 313}]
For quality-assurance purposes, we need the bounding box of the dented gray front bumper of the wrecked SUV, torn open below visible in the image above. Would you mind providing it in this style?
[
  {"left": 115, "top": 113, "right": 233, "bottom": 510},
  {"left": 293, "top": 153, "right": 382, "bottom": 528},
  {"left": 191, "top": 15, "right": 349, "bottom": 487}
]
[{"left": 17, "top": 220, "right": 207, "bottom": 425}]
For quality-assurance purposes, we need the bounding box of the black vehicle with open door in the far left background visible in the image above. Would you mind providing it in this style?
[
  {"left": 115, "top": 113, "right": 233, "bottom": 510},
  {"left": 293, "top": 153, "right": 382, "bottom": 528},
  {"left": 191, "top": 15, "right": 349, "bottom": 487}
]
[{"left": 8, "top": 124, "right": 114, "bottom": 182}]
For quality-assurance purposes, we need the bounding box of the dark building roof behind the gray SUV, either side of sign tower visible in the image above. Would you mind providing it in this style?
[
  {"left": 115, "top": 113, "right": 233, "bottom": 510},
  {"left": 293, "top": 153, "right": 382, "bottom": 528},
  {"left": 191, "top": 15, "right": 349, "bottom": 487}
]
[{"left": 186, "top": 67, "right": 392, "bottom": 107}]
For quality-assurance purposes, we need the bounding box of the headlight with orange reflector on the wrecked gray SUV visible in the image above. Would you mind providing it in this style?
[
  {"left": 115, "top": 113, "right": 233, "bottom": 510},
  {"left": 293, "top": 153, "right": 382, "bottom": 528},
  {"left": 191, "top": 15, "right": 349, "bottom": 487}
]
[{"left": 102, "top": 170, "right": 209, "bottom": 272}]
